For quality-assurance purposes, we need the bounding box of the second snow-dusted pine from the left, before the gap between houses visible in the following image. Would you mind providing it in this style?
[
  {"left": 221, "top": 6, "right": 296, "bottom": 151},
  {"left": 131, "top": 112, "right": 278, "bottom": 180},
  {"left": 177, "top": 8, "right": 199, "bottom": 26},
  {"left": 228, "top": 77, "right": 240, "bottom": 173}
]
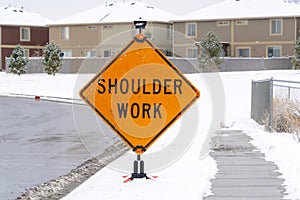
[{"left": 42, "top": 42, "right": 62, "bottom": 76}]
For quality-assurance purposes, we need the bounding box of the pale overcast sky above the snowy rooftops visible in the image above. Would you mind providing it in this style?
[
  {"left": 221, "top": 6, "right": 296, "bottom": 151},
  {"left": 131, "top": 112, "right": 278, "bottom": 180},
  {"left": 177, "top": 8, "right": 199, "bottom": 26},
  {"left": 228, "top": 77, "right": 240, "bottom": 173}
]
[{"left": 0, "top": 0, "right": 222, "bottom": 20}]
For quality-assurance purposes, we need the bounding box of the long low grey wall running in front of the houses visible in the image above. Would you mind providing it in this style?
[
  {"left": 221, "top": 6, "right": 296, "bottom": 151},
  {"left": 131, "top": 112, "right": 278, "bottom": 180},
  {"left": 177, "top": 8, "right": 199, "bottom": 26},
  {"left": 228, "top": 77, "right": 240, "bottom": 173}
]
[{"left": 6, "top": 57, "right": 292, "bottom": 73}]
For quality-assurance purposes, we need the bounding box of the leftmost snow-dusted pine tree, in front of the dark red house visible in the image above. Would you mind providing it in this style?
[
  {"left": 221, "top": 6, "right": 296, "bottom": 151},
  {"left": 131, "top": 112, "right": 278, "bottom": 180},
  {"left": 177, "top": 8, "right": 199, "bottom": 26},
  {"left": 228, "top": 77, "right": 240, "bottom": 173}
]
[{"left": 8, "top": 45, "right": 28, "bottom": 76}]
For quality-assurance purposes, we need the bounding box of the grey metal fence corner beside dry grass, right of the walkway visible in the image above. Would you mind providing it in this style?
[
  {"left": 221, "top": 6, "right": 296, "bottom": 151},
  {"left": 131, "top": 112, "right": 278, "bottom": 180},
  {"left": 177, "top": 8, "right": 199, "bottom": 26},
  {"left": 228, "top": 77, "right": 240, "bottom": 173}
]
[{"left": 251, "top": 78, "right": 300, "bottom": 132}]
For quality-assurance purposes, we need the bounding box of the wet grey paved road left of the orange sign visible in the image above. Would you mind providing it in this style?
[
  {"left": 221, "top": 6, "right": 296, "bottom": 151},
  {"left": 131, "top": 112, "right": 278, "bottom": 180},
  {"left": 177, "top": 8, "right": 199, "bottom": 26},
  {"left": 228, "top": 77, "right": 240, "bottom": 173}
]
[{"left": 0, "top": 97, "right": 115, "bottom": 199}]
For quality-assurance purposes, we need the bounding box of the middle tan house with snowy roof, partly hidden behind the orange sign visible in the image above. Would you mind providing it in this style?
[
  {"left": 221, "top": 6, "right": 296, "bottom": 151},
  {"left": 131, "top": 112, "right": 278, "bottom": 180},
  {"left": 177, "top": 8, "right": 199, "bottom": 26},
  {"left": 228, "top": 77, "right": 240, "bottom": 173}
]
[{"left": 49, "top": 1, "right": 177, "bottom": 57}]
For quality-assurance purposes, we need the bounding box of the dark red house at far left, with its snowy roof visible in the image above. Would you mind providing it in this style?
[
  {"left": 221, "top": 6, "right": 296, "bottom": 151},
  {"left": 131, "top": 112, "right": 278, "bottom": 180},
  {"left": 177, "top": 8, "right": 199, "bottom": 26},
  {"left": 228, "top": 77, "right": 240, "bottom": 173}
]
[{"left": 0, "top": 6, "right": 49, "bottom": 70}]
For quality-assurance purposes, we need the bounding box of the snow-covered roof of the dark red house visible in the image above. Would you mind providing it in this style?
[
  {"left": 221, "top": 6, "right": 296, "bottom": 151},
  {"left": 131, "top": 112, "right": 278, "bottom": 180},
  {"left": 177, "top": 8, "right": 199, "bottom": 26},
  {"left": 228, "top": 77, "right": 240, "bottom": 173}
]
[{"left": 0, "top": 6, "right": 50, "bottom": 26}]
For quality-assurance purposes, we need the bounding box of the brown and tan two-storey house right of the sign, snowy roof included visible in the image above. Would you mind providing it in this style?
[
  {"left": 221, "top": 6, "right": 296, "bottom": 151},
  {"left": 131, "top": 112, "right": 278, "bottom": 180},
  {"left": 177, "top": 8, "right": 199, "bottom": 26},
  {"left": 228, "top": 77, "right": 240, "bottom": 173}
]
[{"left": 174, "top": 0, "right": 300, "bottom": 57}]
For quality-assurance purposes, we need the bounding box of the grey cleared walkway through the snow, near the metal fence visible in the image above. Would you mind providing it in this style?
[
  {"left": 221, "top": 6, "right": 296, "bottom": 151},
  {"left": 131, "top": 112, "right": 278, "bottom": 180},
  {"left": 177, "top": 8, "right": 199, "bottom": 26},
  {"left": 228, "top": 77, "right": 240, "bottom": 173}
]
[{"left": 204, "top": 131, "right": 285, "bottom": 200}]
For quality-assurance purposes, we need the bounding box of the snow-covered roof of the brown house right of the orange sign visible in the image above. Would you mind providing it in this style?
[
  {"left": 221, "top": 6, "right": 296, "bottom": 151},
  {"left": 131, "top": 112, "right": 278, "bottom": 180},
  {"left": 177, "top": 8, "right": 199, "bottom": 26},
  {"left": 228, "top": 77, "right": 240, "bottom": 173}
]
[{"left": 175, "top": 0, "right": 300, "bottom": 21}]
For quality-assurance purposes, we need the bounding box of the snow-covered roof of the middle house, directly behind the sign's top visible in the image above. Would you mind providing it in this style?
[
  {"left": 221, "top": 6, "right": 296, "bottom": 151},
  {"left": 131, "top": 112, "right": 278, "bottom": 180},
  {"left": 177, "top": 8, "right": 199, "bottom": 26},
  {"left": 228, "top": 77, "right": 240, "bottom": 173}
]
[{"left": 52, "top": 2, "right": 177, "bottom": 25}]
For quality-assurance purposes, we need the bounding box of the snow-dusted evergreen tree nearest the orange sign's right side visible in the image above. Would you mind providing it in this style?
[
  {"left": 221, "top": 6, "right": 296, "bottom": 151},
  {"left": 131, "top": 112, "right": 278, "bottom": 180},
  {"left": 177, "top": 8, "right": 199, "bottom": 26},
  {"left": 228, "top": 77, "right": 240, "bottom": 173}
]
[{"left": 198, "top": 31, "right": 224, "bottom": 72}]
